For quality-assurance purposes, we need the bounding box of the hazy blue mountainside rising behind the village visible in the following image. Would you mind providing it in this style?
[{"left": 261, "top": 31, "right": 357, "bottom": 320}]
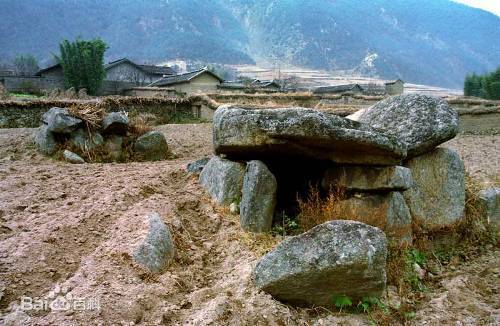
[{"left": 0, "top": 0, "right": 500, "bottom": 88}]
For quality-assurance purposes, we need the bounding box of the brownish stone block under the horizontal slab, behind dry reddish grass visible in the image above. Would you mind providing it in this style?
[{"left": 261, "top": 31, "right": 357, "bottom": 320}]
[{"left": 339, "top": 191, "right": 412, "bottom": 243}]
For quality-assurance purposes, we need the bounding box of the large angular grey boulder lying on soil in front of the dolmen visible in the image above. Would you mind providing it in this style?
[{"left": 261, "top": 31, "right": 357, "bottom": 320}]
[{"left": 252, "top": 221, "right": 387, "bottom": 306}]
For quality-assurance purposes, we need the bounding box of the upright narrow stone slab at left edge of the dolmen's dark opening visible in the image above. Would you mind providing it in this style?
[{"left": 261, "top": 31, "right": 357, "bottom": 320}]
[{"left": 240, "top": 161, "right": 278, "bottom": 232}]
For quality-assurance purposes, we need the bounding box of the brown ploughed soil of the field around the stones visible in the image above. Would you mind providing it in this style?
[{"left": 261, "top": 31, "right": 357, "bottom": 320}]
[{"left": 0, "top": 124, "right": 500, "bottom": 325}]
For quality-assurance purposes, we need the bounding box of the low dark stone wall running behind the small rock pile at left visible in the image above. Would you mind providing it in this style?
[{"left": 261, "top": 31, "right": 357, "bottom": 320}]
[{"left": 0, "top": 97, "right": 193, "bottom": 128}]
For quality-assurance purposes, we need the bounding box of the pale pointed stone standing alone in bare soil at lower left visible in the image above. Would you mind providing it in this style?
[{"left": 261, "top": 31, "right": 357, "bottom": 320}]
[{"left": 133, "top": 213, "right": 175, "bottom": 273}]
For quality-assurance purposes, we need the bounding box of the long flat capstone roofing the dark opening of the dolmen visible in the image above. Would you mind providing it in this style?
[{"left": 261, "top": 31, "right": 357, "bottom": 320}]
[{"left": 213, "top": 105, "right": 406, "bottom": 165}]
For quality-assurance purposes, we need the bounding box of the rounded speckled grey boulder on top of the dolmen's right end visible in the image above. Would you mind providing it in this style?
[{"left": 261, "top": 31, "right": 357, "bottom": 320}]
[{"left": 357, "top": 94, "right": 459, "bottom": 158}]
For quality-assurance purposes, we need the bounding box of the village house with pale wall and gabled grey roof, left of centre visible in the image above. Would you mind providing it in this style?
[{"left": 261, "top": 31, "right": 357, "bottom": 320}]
[{"left": 148, "top": 67, "right": 224, "bottom": 94}]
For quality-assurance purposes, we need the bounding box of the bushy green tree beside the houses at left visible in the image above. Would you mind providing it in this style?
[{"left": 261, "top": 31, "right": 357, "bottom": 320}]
[{"left": 57, "top": 38, "right": 108, "bottom": 95}]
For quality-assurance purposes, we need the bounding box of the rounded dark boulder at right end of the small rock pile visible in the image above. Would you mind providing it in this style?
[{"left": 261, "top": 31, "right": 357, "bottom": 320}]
[{"left": 134, "top": 130, "right": 168, "bottom": 161}]
